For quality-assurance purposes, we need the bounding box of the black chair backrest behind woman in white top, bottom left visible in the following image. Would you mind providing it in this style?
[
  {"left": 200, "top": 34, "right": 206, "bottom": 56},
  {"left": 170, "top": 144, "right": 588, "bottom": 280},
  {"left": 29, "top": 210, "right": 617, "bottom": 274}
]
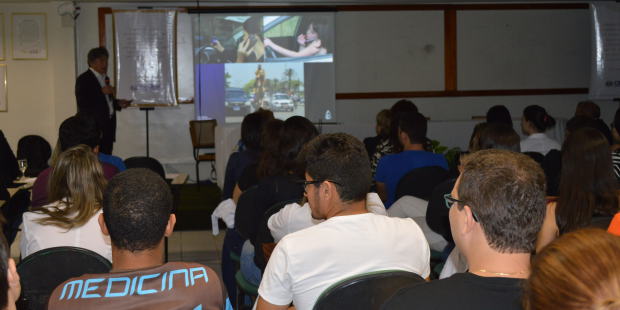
[{"left": 17, "top": 247, "right": 112, "bottom": 309}]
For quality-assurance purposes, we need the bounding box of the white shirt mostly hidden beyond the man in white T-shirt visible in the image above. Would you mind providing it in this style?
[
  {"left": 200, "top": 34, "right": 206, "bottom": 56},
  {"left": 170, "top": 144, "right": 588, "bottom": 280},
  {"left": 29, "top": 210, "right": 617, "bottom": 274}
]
[{"left": 268, "top": 193, "right": 387, "bottom": 242}]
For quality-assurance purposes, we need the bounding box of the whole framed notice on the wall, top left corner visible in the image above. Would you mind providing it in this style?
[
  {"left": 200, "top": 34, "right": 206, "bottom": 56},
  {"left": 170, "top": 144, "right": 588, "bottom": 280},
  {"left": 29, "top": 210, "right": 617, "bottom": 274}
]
[{"left": 11, "top": 13, "right": 47, "bottom": 59}]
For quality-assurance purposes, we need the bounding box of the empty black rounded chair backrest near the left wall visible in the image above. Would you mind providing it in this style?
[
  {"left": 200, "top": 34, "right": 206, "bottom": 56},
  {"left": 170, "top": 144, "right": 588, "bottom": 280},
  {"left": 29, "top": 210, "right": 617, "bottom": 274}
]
[{"left": 17, "top": 135, "right": 52, "bottom": 177}]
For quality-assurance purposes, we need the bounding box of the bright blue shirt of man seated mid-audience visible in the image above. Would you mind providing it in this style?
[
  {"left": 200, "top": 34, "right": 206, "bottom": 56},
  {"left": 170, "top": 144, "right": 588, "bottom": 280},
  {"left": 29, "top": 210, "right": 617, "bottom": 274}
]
[{"left": 375, "top": 151, "right": 448, "bottom": 209}]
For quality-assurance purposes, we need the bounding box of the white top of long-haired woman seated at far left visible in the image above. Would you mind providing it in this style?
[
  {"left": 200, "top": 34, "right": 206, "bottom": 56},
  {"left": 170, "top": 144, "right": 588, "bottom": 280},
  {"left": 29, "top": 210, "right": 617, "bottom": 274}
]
[{"left": 20, "top": 202, "right": 112, "bottom": 261}]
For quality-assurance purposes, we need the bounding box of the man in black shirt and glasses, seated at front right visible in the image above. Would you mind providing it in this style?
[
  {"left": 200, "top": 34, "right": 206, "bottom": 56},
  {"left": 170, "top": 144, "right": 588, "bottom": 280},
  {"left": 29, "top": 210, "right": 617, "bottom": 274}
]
[{"left": 383, "top": 150, "right": 546, "bottom": 309}]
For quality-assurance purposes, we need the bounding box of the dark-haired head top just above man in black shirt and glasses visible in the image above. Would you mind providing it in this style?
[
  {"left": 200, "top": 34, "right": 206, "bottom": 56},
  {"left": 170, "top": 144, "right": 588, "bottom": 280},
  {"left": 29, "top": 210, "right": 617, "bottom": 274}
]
[{"left": 478, "top": 123, "right": 521, "bottom": 153}]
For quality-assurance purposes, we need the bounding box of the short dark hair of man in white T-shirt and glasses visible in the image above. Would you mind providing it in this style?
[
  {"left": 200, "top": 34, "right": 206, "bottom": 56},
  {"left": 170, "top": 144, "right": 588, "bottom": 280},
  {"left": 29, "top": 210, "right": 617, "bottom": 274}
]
[{"left": 299, "top": 133, "right": 371, "bottom": 202}]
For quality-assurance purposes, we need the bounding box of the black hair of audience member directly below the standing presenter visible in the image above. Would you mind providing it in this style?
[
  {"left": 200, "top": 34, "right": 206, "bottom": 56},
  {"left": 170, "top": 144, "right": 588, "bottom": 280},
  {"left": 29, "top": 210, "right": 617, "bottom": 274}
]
[{"left": 58, "top": 113, "right": 101, "bottom": 152}]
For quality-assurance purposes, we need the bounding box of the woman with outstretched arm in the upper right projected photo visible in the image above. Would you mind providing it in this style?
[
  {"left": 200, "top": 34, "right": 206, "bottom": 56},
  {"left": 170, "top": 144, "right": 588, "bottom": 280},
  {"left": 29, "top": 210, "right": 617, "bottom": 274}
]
[{"left": 265, "top": 21, "right": 329, "bottom": 57}]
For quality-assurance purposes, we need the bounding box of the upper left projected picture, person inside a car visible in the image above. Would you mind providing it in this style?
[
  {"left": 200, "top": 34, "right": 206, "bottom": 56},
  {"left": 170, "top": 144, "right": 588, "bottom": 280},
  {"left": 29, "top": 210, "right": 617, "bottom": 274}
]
[{"left": 195, "top": 16, "right": 265, "bottom": 63}]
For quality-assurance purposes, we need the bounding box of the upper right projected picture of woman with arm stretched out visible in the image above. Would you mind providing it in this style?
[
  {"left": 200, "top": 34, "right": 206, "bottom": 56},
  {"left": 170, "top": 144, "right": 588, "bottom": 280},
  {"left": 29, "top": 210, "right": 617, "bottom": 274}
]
[{"left": 263, "top": 15, "right": 334, "bottom": 62}]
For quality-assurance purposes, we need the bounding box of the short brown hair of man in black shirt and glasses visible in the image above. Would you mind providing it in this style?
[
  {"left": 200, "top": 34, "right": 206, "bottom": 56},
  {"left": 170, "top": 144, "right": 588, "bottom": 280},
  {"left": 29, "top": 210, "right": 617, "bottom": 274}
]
[{"left": 458, "top": 150, "right": 546, "bottom": 253}]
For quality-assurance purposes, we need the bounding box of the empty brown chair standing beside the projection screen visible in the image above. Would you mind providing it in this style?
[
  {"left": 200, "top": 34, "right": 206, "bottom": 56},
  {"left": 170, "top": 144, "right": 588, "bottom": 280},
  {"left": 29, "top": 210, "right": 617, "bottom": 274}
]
[{"left": 189, "top": 119, "right": 217, "bottom": 184}]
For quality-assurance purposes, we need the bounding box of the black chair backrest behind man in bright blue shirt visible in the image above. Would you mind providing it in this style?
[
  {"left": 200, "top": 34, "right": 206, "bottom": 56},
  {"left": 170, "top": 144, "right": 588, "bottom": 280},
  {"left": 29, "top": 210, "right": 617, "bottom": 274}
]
[{"left": 394, "top": 166, "right": 449, "bottom": 201}]
